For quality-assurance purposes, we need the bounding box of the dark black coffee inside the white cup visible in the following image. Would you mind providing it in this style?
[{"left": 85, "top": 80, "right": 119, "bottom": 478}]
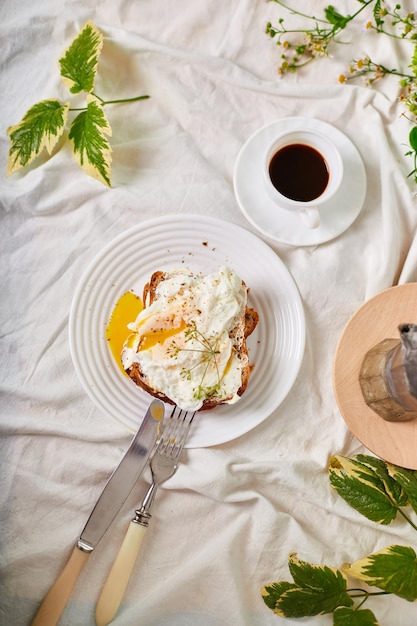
[{"left": 269, "top": 143, "right": 329, "bottom": 202}]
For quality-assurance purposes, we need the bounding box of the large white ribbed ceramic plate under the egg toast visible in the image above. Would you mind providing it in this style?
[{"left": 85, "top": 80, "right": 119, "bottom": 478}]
[{"left": 69, "top": 215, "right": 305, "bottom": 447}]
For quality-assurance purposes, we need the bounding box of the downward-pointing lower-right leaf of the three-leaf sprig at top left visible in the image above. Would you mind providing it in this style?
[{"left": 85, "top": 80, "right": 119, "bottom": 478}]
[{"left": 69, "top": 96, "right": 111, "bottom": 187}]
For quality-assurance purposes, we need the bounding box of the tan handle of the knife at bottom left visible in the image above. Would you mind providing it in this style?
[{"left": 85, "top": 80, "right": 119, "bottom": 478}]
[{"left": 32, "top": 546, "right": 90, "bottom": 626}]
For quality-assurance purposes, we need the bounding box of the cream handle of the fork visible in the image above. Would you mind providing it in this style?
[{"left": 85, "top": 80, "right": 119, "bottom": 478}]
[{"left": 96, "top": 522, "right": 147, "bottom": 626}]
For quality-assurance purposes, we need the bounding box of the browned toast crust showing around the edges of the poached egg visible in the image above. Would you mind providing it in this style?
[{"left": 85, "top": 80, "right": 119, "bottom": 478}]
[{"left": 126, "top": 271, "right": 259, "bottom": 411}]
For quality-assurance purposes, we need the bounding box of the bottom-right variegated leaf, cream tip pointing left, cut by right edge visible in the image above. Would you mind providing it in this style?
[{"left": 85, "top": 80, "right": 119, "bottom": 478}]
[{"left": 346, "top": 545, "right": 417, "bottom": 602}]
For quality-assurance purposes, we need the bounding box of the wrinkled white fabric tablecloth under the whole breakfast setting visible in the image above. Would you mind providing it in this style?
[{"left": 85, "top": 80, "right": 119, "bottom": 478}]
[{"left": 0, "top": 0, "right": 417, "bottom": 626}]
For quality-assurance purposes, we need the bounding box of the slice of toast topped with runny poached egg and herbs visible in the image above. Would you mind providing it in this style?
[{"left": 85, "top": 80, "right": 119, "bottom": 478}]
[{"left": 122, "top": 268, "right": 258, "bottom": 410}]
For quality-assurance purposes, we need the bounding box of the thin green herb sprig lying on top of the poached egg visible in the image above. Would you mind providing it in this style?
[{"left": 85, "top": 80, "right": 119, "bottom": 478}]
[{"left": 167, "top": 321, "right": 221, "bottom": 400}]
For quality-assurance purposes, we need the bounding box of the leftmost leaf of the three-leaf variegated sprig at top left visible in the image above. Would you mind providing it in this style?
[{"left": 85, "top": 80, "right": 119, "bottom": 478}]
[{"left": 7, "top": 99, "right": 69, "bottom": 176}]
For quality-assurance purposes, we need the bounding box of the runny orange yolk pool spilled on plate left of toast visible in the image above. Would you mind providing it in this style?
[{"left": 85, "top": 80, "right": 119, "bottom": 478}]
[{"left": 106, "top": 291, "right": 143, "bottom": 376}]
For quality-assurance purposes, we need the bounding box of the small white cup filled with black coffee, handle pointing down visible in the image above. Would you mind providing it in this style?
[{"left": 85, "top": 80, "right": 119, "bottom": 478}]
[{"left": 264, "top": 130, "right": 343, "bottom": 228}]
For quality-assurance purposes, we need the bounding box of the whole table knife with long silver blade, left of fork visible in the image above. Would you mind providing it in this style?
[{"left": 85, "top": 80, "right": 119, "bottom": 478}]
[{"left": 32, "top": 400, "right": 165, "bottom": 626}]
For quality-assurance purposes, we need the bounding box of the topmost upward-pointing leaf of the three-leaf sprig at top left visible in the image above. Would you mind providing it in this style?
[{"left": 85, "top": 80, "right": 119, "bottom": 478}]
[{"left": 59, "top": 22, "right": 103, "bottom": 93}]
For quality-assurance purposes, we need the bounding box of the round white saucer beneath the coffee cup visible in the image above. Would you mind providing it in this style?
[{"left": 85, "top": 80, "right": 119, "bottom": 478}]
[{"left": 233, "top": 117, "right": 366, "bottom": 246}]
